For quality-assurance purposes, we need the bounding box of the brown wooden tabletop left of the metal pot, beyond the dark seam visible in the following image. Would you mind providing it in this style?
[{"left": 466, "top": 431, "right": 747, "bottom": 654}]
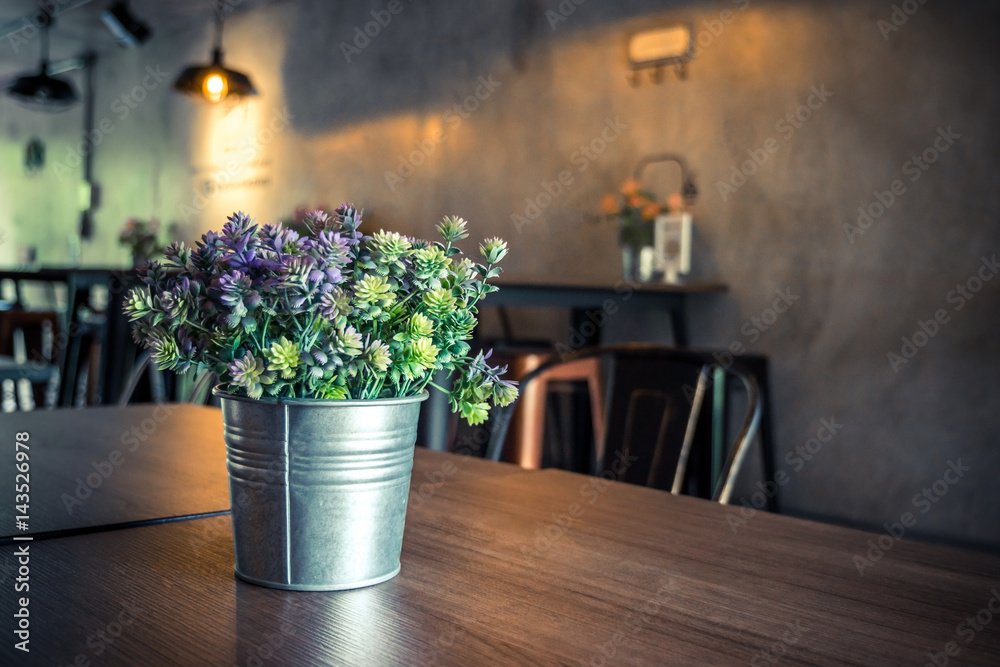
[{"left": 0, "top": 405, "right": 229, "bottom": 542}]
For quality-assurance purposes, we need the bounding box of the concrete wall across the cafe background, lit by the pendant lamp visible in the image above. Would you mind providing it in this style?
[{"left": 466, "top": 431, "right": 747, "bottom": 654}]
[{"left": 0, "top": 0, "right": 1000, "bottom": 549}]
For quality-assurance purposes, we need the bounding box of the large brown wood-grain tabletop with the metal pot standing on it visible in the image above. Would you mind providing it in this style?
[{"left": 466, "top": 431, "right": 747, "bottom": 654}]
[{"left": 0, "top": 408, "right": 1000, "bottom": 667}]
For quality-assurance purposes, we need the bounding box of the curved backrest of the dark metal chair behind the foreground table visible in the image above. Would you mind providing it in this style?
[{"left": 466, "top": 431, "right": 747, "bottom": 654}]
[{"left": 486, "top": 344, "right": 762, "bottom": 503}]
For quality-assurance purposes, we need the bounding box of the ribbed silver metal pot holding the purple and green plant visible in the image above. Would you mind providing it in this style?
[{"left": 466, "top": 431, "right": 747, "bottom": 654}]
[{"left": 214, "top": 387, "right": 427, "bottom": 591}]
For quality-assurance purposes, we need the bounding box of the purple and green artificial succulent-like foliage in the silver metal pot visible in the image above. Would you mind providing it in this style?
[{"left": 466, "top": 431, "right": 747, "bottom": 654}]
[{"left": 126, "top": 204, "right": 517, "bottom": 424}]
